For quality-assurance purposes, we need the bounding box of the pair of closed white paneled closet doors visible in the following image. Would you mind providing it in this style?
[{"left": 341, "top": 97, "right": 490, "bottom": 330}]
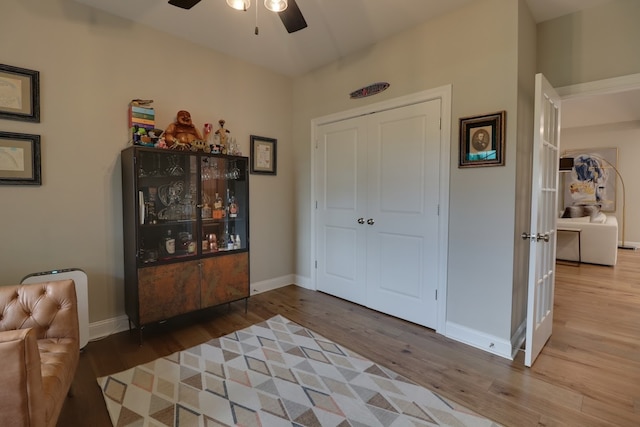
[{"left": 315, "top": 99, "right": 446, "bottom": 328}]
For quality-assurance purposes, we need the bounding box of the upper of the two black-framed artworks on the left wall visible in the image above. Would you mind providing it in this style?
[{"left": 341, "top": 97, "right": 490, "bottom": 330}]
[{"left": 0, "top": 64, "right": 40, "bottom": 123}]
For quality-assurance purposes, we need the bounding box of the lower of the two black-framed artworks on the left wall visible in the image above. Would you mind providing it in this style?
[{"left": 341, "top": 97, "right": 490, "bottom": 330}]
[{"left": 0, "top": 132, "right": 42, "bottom": 185}]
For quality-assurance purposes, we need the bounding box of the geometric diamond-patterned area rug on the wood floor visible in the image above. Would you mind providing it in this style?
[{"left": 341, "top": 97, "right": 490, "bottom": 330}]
[{"left": 98, "top": 316, "right": 497, "bottom": 427}]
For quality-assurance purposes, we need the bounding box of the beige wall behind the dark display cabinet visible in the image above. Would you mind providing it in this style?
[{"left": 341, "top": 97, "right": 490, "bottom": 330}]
[{"left": 0, "top": 0, "right": 295, "bottom": 322}]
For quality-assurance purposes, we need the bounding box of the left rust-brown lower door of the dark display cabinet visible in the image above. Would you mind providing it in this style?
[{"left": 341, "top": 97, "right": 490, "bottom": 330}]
[{"left": 138, "top": 261, "right": 200, "bottom": 325}]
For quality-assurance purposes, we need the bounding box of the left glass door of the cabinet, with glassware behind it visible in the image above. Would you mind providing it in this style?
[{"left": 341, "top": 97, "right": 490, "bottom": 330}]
[{"left": 136, "top": 150, "right": 198, "bottom": 265}]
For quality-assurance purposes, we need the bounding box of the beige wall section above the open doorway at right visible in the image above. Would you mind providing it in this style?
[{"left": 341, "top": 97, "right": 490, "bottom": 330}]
[{"left": 538, "top": 0, "right": 640, "bottom": 87}]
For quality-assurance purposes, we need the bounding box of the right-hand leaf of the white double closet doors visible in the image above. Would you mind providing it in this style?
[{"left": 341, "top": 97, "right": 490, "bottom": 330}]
[{"left": 367, "top": 100, "right": 440, "bottom": 328}]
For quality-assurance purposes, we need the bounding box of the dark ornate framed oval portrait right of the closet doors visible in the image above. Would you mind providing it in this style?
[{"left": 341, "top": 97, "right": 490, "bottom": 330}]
[{"left": 458, "top": 111, "right": 507, "bottom": 168}]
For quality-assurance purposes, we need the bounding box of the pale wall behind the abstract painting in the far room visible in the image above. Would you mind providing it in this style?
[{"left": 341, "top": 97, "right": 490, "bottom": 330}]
[{"left": 560, "top": 122, "right": 640, "bottom": 245}]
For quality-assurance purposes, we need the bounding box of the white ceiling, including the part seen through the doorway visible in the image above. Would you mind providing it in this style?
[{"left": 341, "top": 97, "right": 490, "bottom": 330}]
[{"left": 76, "top": 0, "right": 640, "bottom": 127}]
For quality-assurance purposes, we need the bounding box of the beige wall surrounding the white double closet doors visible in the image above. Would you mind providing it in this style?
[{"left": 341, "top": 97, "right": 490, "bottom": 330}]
[{"left": 293, "top": 0, "right": 534, "bottom": 348}]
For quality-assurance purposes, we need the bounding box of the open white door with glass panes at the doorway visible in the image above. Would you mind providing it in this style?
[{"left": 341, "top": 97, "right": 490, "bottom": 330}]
[{"left": 522, "top": 74, "right": 560, "bottom": 366}]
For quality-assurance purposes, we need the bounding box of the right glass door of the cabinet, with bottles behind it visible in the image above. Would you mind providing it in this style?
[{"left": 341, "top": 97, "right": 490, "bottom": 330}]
[{"left": 200, "top": 156, "right": 248, "bottom": 254}]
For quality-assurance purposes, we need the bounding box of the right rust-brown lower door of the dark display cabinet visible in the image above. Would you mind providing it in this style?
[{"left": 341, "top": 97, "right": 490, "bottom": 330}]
[{"left": 201, "top": 252, "right": 249, "bottom": 308}]
